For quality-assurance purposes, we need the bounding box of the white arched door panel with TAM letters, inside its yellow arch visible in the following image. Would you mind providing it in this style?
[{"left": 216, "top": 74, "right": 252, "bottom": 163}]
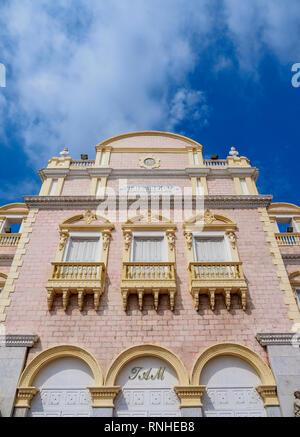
[{"left": 114, "top": 357, "right": 181, "bottom": 417}]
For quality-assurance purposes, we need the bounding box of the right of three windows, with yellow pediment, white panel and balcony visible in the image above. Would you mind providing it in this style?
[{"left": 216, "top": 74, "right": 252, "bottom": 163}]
[{"left": 183, "top": 209, "right": 247, "bottom": 311}]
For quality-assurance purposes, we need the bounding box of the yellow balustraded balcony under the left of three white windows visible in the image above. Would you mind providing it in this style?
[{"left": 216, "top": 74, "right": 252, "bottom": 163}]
[{"left": 46, "top": 262, "right": 105, "bottom": 311}]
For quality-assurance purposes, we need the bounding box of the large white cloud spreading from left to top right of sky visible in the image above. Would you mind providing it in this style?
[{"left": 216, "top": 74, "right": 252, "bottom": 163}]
[{"left": 0, "top": 0, "right": 300, "bottom": 166}]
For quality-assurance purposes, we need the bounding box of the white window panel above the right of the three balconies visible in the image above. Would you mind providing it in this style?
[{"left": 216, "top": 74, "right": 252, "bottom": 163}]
[{"left": 195, "top": 237, "right": 228, "bottom": 262}]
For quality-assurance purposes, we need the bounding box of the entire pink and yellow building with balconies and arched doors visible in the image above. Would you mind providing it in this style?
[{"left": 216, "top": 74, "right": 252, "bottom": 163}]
[{"left": 0, "top": 132, "right": 300, "bottom": 417}]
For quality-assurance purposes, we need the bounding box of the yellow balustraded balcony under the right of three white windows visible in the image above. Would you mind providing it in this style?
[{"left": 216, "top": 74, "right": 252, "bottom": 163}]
[{"left": 189, "top": 262, "right": 247, "bottom": 311}]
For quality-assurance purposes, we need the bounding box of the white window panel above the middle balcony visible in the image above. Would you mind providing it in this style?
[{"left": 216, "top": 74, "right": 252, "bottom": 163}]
[{"left": 133, "top": 237, "right": 163, "bottom": 262}]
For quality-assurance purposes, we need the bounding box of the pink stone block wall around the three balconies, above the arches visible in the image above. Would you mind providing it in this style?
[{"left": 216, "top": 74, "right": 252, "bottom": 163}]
[{"left": 6, "top": 206, "right": 292, "bottom": 370}]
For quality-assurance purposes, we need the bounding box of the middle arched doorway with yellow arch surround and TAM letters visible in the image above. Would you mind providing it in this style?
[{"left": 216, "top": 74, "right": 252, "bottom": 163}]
[{"left": 105, "top": 344, "right": 189, "bottom": 417}]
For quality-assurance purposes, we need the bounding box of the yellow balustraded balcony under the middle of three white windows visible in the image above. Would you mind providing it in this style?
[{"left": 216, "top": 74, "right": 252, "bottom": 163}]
[{"left": 121, "top": 262, "right": 176, "bottom": 311}]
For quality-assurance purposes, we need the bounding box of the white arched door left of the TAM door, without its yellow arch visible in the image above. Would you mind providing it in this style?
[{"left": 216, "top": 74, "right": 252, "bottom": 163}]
[{"left": 28, "top": 357, "right": 94, "bottom": 417}]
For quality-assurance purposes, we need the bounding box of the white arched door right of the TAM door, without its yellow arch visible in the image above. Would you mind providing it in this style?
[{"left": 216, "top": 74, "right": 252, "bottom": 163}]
[{"left": 200, "top": 356, "right": 266, "bottom": 417}]
